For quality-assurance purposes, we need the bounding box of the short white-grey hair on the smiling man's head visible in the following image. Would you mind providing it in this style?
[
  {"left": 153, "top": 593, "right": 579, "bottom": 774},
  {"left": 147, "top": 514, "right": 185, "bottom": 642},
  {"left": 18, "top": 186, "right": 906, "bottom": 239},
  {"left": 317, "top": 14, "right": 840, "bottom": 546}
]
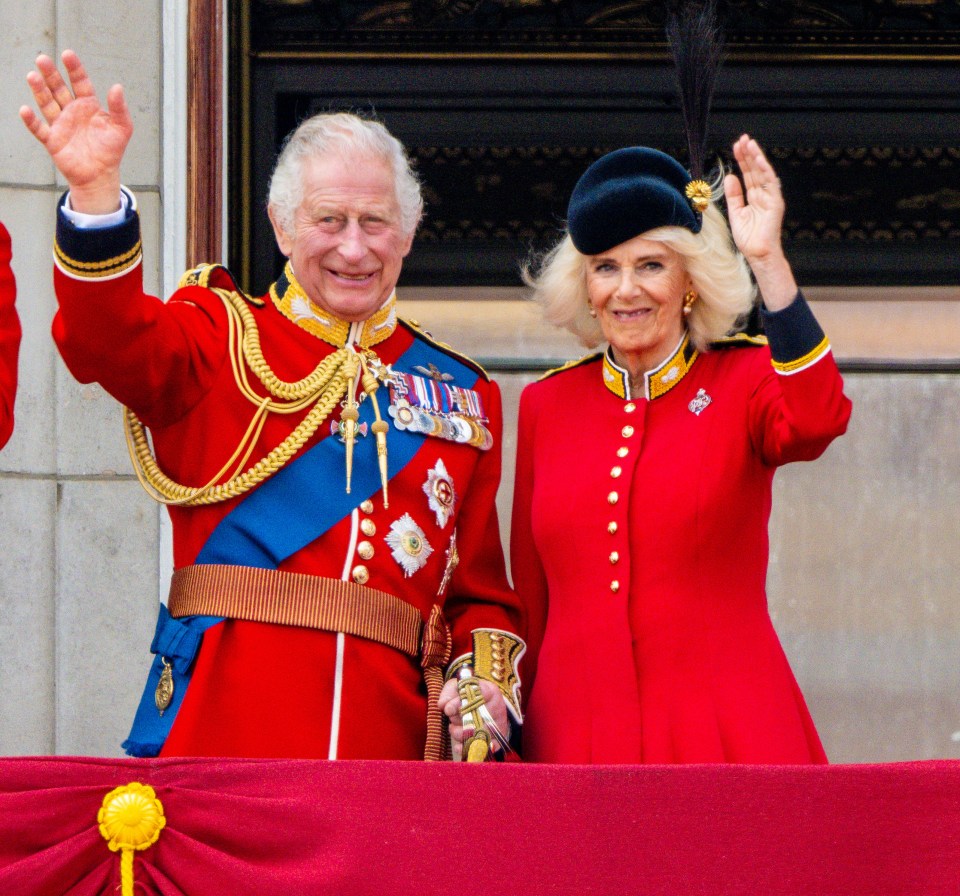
[{"left": 268, "top": 112, "right": 423, "bottom": 236}]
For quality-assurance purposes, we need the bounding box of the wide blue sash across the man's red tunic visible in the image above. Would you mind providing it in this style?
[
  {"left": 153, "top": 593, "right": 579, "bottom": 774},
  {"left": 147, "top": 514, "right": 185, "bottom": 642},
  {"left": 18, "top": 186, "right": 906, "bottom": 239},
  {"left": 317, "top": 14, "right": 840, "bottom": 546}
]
[{"left": 123, "top": 338, "right": 477, "bottom": 757}]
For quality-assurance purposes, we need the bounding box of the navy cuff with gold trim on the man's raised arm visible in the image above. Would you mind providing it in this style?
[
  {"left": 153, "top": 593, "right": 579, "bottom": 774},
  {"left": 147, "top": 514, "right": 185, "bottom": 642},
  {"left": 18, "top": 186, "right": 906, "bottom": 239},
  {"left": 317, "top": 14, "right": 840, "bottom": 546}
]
[{"left": 53, "top": 193, "right": 142, "bottom": 280}]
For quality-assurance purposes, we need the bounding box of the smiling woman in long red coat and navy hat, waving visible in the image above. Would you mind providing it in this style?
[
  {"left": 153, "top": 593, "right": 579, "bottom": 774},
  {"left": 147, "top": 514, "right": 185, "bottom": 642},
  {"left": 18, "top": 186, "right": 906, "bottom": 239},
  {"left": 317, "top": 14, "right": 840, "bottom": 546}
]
[{"left": 511, "top": 135, "right": 850, "bottom": 763}]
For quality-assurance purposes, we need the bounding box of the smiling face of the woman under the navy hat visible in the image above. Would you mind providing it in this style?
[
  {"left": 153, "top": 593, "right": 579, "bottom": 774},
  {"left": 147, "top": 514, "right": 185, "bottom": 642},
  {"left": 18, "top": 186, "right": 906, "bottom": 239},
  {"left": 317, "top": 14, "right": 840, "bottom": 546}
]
[{"left": 586, "top": 234, "right": 693, "bottom": 376}]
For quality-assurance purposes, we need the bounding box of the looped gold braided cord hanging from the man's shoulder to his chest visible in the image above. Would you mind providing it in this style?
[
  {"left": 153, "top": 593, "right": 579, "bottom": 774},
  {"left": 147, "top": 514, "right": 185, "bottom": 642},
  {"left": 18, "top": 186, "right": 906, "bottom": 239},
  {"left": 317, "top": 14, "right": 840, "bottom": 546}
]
[{"left": 124, "top": 289, "right": 350, "bottom": 507}]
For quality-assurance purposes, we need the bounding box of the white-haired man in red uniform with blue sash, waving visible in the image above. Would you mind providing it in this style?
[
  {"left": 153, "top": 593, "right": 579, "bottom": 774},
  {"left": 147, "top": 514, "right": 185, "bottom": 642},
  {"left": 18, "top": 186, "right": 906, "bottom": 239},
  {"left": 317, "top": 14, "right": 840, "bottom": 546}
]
[{"left": 21, "top": 51, "right": 523, "bottom": 759}]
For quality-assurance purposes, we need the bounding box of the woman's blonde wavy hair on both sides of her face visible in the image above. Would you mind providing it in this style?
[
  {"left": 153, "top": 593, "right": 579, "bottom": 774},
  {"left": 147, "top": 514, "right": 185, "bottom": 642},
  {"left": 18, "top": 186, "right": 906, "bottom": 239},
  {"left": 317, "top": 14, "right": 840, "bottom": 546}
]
[{"left": 522, "top": 202, "right": 757, "bottom": 351}]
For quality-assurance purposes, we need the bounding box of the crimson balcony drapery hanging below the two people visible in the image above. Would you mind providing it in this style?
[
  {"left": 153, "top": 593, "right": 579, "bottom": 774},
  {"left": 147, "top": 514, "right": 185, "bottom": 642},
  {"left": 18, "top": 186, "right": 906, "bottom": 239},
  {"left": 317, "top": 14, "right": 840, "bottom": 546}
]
[{"left": 0, "top": 757, "right": 960, "bottom": 896}]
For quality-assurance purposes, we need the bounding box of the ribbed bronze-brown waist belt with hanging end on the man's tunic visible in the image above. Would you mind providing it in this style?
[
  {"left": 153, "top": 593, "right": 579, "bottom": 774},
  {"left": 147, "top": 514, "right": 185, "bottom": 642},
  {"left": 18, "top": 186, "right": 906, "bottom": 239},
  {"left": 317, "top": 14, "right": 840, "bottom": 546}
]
[{"left": 167, "top": 564, "right": 451, "bottom": 760}]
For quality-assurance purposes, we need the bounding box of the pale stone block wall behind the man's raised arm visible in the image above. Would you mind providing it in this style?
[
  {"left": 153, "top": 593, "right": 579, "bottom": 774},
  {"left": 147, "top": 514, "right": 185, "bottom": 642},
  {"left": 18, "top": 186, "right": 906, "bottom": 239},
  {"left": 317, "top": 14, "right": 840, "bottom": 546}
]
[{"left": 0, "top": 8, "right": 163, "bottom": 755}]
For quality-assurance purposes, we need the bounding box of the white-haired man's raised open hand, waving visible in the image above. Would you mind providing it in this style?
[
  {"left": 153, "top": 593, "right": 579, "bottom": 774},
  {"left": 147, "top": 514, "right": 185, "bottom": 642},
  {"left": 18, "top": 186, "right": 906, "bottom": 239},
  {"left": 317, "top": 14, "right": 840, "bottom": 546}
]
[{"left": 20, "top": 50, "right": 133, "bottom": 214}]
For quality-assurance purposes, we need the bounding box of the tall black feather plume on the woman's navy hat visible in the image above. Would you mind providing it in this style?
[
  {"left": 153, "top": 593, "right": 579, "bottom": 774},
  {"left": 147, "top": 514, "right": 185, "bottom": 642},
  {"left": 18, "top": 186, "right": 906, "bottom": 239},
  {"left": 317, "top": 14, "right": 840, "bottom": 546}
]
[{"left": 666, "top": 0, "right": 723, "bottom": 178}]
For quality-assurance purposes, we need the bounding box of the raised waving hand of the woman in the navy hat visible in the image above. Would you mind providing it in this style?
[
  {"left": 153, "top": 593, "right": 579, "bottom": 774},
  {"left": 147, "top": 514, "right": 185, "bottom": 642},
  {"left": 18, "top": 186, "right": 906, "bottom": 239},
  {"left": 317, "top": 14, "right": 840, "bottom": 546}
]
[{"left": 723, "top": 134, "right": 797, "bottom": 311}]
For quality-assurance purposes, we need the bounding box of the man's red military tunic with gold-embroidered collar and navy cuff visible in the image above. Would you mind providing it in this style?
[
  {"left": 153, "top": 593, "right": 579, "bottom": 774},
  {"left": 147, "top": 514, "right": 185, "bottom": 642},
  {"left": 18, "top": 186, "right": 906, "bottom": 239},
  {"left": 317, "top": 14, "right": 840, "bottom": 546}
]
[{"left": 53, "top": 192, "right": 519, "bottom": 759}]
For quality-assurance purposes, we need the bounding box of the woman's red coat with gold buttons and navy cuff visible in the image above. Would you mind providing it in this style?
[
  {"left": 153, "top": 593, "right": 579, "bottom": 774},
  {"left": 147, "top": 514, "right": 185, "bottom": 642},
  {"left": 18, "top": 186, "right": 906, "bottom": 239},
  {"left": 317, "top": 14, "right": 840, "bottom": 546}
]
[{"left": 511, "top": 297, "right": 850, "bottom": 763}]
